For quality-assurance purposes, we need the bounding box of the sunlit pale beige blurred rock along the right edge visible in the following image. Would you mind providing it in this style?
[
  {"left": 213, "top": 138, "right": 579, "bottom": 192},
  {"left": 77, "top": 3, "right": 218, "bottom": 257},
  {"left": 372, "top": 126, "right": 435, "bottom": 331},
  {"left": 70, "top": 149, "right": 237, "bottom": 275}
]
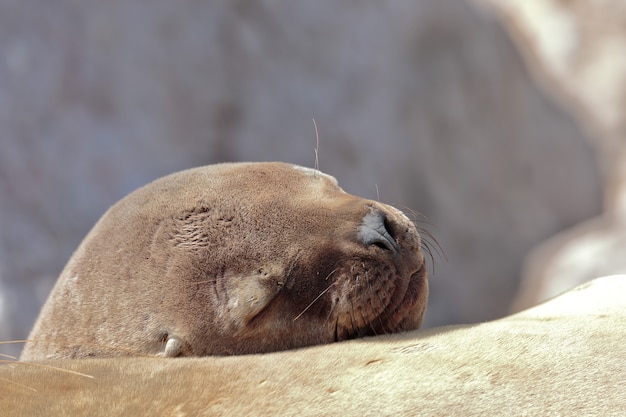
[{"left": 479, "top": 0, "right": 626, "bottom": 310}]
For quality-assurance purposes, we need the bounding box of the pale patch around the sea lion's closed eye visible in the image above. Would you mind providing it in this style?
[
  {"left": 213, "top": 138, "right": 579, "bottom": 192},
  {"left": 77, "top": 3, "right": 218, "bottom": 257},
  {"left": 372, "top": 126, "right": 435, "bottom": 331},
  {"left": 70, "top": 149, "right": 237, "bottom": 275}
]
[{"left": 224, "top": 268, "right": 284, "bottom": 331}]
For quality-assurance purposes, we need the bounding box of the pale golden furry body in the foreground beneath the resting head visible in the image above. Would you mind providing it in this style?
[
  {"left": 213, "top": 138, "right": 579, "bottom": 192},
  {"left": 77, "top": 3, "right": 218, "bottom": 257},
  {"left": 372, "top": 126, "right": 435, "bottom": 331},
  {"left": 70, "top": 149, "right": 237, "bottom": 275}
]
[{"left": 0, "top": 276, "right": 626, "bottom": 417}]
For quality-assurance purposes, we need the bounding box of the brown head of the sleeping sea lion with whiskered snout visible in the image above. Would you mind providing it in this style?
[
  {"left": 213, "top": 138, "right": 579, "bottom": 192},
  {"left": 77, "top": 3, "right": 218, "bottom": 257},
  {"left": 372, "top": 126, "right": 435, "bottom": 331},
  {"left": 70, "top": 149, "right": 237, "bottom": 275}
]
[{"left": 21, "top": 163, "right": 428, "bottom": 360}]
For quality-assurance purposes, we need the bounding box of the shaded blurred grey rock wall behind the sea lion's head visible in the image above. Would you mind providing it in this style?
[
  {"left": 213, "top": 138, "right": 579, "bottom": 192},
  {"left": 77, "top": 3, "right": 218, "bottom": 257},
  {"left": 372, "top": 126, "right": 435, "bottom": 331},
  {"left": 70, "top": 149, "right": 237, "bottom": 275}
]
[{"left": 0, "top": 0, "right": 604, "bottom": 353}]
